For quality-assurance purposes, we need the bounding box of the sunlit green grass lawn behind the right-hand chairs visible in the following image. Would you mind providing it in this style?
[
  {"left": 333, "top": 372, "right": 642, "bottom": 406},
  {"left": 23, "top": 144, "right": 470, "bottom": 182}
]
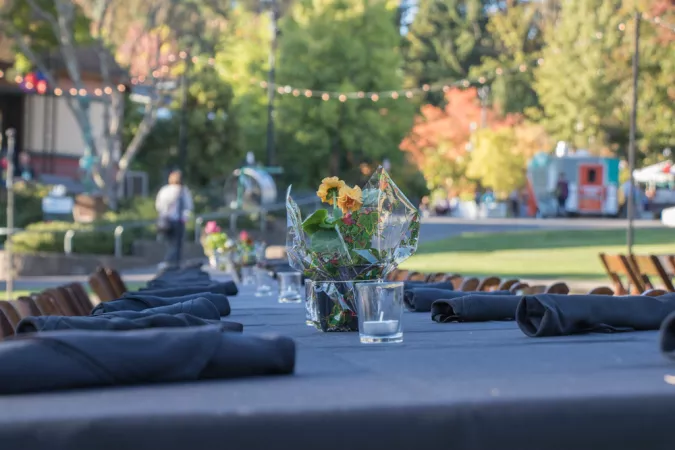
[{"left": 402, "top": 229, "right": 675, "bottom": 280}]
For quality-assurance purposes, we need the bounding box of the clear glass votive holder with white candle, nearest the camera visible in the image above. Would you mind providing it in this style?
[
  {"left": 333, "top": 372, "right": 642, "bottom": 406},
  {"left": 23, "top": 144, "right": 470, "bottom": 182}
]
[{"left": 356, "top": 281, "right": 403, "bottom": 344}]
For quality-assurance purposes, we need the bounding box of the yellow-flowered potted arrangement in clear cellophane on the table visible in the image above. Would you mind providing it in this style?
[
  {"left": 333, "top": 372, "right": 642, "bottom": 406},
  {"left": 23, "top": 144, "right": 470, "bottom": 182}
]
[{"left": 286, "top": 167, "right": 420, "bottom": 331}]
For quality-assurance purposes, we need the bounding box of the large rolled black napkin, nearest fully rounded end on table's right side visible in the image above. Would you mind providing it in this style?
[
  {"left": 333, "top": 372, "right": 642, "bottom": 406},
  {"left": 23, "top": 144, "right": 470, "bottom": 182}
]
[{"left": 516, "top": 294, "right": 675, "bottom": 337}]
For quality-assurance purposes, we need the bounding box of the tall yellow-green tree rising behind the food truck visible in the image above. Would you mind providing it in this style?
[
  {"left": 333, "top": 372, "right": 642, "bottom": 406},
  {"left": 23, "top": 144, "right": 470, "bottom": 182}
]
[{"left": 534, "top": 0, "right": 626, "bottom": 148}]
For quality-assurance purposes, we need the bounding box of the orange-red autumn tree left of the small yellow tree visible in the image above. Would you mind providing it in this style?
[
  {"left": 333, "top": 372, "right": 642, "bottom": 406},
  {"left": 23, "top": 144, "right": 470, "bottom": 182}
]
[{"left": 400, "top": 88, "right": 520, "bottom": 189}]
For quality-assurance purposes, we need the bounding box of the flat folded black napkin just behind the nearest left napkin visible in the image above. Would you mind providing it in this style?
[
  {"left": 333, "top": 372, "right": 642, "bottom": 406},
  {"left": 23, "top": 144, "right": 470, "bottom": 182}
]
[{"left": 16, "top": 313, "right": 244, "bottom": 334}]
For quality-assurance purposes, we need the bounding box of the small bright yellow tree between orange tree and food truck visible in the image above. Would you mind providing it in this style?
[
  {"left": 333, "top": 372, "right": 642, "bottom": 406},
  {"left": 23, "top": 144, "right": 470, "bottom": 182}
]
[{"left": 467, "top": 127, "right": 527, "bottom": 195}]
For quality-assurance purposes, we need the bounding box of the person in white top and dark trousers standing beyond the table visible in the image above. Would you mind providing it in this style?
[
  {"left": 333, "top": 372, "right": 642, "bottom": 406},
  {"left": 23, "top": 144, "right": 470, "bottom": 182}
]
[{"left": 155, "top": 170, "right": 194, "bottom": 267}]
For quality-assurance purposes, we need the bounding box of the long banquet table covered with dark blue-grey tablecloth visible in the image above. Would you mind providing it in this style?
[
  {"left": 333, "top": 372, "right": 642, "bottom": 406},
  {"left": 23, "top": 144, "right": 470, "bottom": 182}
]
[{"left": 0, "top": 289, "right": 675, "bottom": 450}]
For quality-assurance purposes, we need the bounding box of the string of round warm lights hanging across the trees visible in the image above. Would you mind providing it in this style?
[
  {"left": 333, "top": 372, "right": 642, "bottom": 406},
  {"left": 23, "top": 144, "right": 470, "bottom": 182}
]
[{"left": 0, "top": 14, "right": 675, "bottom": 102}]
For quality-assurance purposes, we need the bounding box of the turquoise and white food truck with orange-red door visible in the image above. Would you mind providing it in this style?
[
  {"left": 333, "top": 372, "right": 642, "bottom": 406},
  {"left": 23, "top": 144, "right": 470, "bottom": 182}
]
[{"left": 527, "top": 150, "right": 619, "bottom": 217}]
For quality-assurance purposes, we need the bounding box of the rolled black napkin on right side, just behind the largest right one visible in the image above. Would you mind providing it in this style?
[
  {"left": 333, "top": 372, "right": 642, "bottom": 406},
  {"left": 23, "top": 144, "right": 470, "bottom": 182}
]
[{"left": 431, "top": 291, "right": 522, "bottom": 323}]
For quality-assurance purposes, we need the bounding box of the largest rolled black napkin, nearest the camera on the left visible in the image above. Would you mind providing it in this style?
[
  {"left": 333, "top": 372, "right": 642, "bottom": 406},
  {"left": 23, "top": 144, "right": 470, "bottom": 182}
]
[{"left": 0, "top": 326, "right": 295, "bottom": 394}]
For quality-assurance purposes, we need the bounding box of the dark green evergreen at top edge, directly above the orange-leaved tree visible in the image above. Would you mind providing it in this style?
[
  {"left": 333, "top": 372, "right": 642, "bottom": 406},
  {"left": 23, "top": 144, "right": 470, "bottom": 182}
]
[{"left": 404, "top": 0, "right": 498, "bottom": 106}]
